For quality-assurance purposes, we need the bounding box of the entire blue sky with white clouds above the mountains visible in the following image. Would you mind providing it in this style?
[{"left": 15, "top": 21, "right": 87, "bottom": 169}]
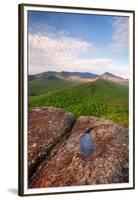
[{"left": 28, "top": 11, "right": 129, "bottom": 78}]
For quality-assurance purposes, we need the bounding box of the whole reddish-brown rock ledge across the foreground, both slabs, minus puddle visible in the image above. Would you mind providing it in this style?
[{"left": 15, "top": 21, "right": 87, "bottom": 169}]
[{"left": 29, "top": 108, "right": 129, "bottom": 188}]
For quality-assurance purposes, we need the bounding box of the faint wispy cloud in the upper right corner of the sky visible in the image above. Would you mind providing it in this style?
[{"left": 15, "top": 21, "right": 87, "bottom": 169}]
[{"left": 110, "top": 17, "right": 129, "bottom": 53}]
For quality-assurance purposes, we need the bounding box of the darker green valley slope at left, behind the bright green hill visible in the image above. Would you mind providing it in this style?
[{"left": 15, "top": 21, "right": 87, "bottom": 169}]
[{"left": 28, "top": 79, "right": 80, "bottom": 96}]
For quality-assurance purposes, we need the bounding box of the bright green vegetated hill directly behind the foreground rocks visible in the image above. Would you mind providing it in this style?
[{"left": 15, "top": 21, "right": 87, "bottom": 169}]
[{"left": 29, "top": 80, "right": 128, "bottom": 127}]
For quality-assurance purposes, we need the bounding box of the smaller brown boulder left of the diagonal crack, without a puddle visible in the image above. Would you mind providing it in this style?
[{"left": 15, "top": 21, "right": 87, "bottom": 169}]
[{"left": 28, "top": 107, "right": 75, "bottom": 177}]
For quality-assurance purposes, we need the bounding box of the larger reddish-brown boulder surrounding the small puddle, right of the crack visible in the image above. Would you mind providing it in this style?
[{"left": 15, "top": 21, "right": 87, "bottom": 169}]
[{"left": 29, "top": 110, "right": 129, "bottom": 188}]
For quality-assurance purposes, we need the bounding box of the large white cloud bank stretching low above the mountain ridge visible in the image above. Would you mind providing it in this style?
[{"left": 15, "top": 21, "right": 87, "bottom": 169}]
[{"left": 29, "top": 33, "right": 128, "bottom": 77}]
